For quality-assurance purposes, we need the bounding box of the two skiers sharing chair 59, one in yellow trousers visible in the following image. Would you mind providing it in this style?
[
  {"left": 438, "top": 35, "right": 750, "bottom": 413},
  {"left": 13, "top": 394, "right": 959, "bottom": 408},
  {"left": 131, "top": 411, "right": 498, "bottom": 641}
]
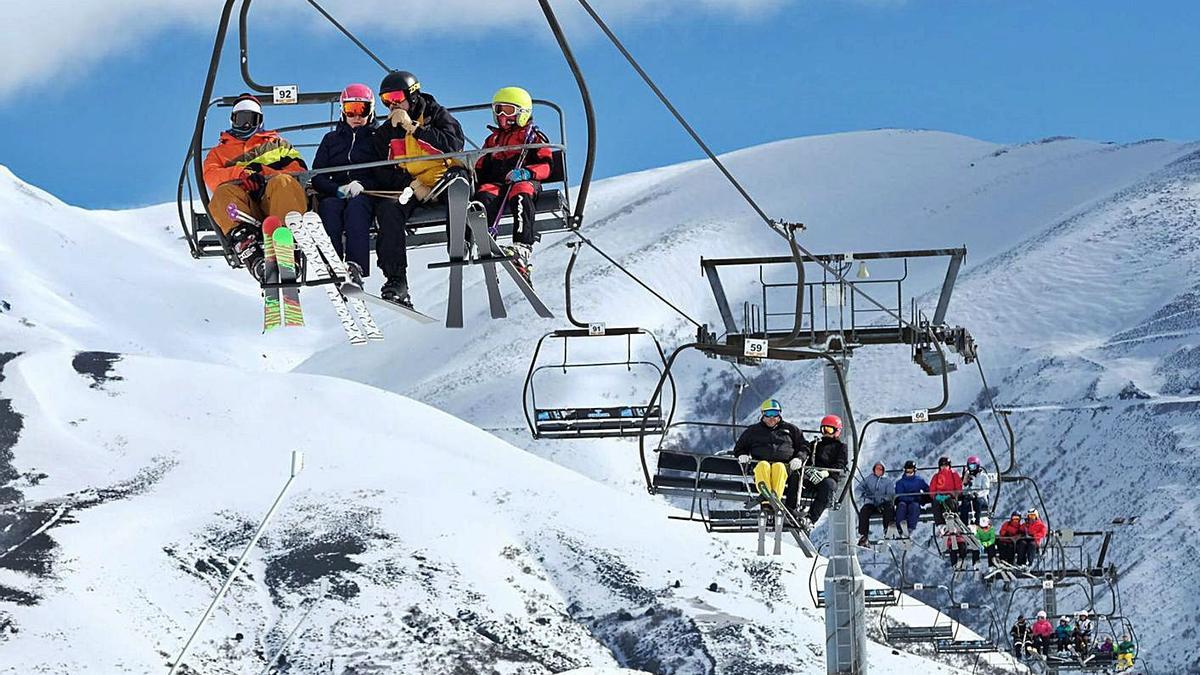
[{"left": 733, "top": 399, "right": 848, "bottom": 532}]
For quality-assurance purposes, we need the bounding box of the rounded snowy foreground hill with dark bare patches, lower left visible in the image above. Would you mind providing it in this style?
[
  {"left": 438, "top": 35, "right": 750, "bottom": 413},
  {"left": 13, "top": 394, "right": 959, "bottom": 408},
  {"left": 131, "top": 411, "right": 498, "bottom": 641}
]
[{"left": 0, "top": 343, "right": 974, "bottom": 674}]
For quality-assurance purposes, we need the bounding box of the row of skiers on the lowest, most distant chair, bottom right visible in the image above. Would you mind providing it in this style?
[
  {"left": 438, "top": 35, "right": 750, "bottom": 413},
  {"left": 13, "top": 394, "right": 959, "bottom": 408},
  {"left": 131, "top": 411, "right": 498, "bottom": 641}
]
[{"left": 1008, "top": 611, "right": 1138, "bottom": 670}]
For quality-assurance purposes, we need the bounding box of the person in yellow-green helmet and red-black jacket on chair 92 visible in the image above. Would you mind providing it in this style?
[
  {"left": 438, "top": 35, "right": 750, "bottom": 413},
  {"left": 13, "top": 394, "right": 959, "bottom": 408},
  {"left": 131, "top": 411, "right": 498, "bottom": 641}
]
[{"left": 475, "top": 86, "right": 554, "bottom": 283}]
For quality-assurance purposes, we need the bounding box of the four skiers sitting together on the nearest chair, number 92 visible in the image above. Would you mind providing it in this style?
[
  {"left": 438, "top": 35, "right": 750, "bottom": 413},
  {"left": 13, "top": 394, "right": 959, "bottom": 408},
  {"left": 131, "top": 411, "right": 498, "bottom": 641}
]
[{"left": 204, "top": 71, "right": 556, "bottom": 307}]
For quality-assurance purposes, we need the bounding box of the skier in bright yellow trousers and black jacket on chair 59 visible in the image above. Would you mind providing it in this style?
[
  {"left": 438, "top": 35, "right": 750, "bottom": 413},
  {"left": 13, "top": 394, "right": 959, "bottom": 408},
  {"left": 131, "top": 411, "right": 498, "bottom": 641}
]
[{"left": 733, "top": 399, "right": 808, "bottom": 510}]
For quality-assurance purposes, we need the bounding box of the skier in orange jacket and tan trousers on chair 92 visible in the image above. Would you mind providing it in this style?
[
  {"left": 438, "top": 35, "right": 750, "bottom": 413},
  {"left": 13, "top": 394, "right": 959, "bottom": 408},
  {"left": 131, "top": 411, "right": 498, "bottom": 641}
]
[{"left": 204, "top": 94, "right": 308, "bottom": 278}]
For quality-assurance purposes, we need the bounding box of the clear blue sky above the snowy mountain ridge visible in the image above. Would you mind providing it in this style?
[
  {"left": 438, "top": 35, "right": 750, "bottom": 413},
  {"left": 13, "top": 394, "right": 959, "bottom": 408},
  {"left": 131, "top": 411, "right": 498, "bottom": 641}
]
[{"left": 0, "top": 0, "right": 1200, "bottom": 208}]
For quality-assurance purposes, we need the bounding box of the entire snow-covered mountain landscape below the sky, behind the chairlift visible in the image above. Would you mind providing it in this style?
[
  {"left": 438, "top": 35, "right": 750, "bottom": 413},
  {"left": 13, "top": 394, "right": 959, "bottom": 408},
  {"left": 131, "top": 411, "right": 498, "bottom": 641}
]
[{"left": 0, "top": 131, "right": 1200, "bottom": 673}]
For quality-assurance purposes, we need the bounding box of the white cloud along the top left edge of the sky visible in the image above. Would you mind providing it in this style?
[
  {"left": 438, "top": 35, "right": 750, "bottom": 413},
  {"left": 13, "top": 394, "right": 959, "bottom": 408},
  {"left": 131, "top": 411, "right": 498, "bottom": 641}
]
[{"left": 0, "top": 0, "right": 793, "bottom": 100}]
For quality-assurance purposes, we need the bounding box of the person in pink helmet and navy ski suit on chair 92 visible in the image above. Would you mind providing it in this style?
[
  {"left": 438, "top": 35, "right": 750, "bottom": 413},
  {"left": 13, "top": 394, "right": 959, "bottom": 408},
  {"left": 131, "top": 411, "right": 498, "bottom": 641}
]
[{"left": 312, "top": 84, "right": 384, "bottom": 276}]
